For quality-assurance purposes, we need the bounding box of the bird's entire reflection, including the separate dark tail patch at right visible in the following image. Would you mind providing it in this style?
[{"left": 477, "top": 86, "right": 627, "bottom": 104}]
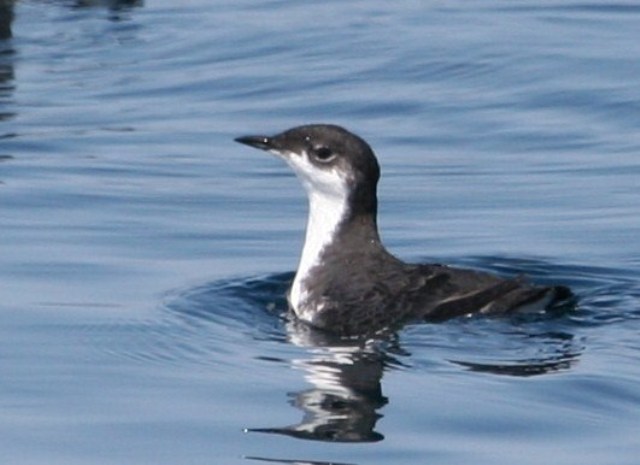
[{"left": 248, "top": 312, "right": 581, "bottom": 442}]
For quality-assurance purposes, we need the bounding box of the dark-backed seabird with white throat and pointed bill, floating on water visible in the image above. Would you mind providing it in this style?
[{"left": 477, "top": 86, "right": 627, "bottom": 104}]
[{"left": 235, "top": 124, "right": 571, "bottom": 337}]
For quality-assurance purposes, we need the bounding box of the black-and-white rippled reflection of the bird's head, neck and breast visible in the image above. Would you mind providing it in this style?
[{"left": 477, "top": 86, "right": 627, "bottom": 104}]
[{"left": 249, "top": 322, "right": 390, "bottom": 442}]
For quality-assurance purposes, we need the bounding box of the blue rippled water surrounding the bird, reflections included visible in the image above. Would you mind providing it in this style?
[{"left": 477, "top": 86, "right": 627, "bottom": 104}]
[{"left": 0, "top": 0, "right": 640, "bottom": 465}]
